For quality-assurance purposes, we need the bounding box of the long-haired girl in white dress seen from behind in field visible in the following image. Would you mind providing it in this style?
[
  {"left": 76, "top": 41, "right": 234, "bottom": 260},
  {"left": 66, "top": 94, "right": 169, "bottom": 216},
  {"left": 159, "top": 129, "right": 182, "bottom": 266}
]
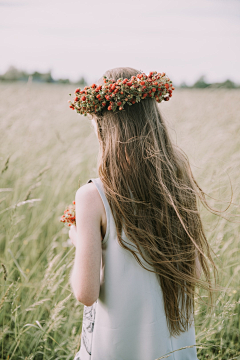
[{"left": 69, "top": 68, "right": 215, "bottom": 360}]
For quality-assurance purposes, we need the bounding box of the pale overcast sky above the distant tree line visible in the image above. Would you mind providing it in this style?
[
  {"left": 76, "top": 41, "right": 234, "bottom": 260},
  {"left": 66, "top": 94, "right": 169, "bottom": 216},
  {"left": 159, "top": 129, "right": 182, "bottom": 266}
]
[{"left": 0, "top": 0, "right": 240, "bottom": 85}]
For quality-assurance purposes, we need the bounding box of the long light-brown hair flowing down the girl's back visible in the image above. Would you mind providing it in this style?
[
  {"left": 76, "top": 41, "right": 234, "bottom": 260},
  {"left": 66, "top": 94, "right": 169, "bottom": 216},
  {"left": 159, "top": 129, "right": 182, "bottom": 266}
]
[{"left": 93, "top": 68, "right": 216, "bottom": 335}]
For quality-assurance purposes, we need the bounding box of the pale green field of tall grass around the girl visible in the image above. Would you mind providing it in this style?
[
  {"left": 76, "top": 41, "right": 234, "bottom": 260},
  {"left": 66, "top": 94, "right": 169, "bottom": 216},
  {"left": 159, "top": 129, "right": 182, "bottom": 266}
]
[{"left": 0, "top": 83, "right": 240, "bottom": 360}]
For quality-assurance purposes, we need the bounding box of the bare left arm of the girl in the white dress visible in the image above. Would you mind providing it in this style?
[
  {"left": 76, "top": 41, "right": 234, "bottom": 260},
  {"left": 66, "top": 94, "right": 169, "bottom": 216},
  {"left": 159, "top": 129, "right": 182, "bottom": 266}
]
[{"left": 69, "top": 183, "right": 105, "bottom": 306}]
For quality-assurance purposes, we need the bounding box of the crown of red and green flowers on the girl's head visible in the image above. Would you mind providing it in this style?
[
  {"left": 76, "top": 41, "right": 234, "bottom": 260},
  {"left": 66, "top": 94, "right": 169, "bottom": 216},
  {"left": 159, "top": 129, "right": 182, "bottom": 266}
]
[{"left": 68, "top": 71, "right": 175, "bottom": 116}]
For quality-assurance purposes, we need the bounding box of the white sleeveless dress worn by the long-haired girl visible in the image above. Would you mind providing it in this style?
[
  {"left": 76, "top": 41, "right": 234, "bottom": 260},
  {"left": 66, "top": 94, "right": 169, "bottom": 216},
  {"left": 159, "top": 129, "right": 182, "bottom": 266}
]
[{"left": 73, "top": 178, "right": 198, "bottom": 360}]
